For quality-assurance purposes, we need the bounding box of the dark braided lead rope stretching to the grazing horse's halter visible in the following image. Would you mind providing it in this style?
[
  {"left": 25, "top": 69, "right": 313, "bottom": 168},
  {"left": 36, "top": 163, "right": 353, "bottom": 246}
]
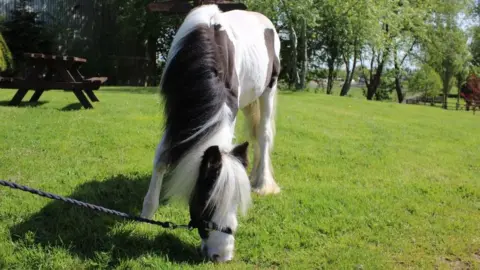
[{"left": 0, "top": 179, "right": 232, "bottom": 234}]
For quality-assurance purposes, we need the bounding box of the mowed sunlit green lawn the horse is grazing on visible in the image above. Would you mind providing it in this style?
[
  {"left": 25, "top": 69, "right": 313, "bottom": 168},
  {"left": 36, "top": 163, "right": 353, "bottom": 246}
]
[{"left": 0, "top": 88, "right": 480, "bottom": 269}]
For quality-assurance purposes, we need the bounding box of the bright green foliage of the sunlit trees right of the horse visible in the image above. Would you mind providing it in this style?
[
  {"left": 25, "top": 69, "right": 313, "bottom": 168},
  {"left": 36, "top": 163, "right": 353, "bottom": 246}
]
[{"left": 246, "top": 0, "right": 475, "bottom": 98}]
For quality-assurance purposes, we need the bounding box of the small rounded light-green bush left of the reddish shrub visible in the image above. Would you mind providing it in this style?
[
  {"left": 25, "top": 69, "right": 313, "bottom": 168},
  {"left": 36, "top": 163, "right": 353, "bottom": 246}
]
[{"left": 408, "top": 65, "right": 443, "bottom": 97}]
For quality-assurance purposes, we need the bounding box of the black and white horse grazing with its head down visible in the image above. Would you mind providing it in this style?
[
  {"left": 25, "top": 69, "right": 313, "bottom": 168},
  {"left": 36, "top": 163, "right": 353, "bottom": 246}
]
[{"left": 141, "top": 5, "right": 280, "bottom": 262}]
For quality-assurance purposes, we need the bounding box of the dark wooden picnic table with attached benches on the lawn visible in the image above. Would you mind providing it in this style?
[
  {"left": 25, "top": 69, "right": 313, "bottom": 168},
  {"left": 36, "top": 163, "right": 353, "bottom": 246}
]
[{"left": 0, "top": 53, "right": 107, "bottom": 109}]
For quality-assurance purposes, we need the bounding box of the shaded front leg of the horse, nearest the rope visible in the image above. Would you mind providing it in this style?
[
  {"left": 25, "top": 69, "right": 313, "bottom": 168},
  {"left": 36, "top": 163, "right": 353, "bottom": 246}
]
[{"left": 141, "top": 139, "right": 167, "bottom": 218}]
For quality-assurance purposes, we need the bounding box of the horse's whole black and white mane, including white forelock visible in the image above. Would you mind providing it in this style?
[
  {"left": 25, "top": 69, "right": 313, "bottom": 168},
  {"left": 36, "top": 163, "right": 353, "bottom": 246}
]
[{"left": 160, "top": 6, "right": 250, "bottom": 218}]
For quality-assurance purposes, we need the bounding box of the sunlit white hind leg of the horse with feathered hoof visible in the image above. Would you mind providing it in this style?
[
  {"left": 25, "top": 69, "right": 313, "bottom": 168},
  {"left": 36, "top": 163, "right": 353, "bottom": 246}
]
[{"left": 252, "top": 82, "right": 280, "bottom": 195}]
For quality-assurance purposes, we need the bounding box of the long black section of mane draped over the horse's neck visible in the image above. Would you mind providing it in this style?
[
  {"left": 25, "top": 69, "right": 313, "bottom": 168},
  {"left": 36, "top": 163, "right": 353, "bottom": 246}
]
[{"left": 160, "top": 24, "right": 238, "bottom": 164}]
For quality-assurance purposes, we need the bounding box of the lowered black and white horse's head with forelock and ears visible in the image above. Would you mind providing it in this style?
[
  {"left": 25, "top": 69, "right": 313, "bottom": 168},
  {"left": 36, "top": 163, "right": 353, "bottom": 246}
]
[{"left": 190, "top": 142, "right": 250, "bottom": 262}]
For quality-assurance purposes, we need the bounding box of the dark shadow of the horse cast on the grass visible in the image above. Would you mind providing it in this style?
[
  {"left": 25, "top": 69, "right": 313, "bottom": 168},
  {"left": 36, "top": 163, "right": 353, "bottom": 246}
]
[{"left": 10, "top": 175, "right": 203, "bottom": 267}]
